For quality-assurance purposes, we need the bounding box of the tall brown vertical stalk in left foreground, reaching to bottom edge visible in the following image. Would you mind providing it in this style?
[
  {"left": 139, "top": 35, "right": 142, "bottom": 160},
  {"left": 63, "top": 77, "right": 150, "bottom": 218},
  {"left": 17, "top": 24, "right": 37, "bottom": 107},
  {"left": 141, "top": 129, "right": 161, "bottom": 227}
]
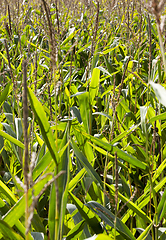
[{"left": 23, "top": 60, "right": 29, "bottom": 240}]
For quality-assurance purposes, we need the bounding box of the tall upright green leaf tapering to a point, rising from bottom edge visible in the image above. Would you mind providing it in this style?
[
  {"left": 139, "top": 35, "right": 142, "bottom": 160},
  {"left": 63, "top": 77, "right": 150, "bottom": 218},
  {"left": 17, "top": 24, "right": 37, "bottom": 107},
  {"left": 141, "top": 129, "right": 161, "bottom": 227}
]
[{"left": 48, "top": 125, "right": 69, "bottom": 240}]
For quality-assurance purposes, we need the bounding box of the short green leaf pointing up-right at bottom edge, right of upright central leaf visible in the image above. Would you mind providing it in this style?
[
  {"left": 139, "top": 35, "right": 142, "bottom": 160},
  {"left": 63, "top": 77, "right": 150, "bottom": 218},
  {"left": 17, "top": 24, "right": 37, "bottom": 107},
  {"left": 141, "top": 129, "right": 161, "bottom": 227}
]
[{"left": 66, "top": 220, "right": 85, "bottom": 240}]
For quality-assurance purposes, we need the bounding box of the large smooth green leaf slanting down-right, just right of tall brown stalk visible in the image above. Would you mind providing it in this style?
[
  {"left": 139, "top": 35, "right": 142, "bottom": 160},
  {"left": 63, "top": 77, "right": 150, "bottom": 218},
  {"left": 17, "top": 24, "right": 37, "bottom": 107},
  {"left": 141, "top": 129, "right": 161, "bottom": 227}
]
[{"left": 28, "top": 88, "right": 58, "bottom": 164}]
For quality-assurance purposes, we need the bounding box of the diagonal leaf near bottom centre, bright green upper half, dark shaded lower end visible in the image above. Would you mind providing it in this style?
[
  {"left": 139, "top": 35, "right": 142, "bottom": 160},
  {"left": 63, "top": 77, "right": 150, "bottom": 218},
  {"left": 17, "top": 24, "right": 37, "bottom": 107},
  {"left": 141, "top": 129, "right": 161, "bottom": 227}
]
[{"left": 69, "top": 192, "right": 103, "bottom": 234}]
